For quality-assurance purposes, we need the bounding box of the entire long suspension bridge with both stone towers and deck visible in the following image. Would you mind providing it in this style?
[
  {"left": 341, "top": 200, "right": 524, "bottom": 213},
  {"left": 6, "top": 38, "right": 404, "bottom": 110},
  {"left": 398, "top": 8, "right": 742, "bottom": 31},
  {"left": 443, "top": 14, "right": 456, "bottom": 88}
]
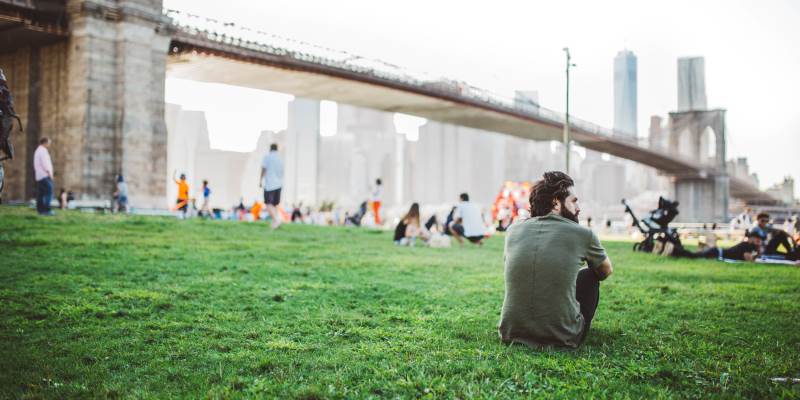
[{"left": 0, "top": 0, "right": 775, "bottom": 220}]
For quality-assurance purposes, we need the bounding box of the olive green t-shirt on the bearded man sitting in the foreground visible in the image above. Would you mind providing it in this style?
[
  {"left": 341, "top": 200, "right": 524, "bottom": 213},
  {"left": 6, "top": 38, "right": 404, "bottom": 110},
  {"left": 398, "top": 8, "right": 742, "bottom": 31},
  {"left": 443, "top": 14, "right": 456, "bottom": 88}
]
[{"left": 498, "top": 213, "right": 606, "bottom": 348}]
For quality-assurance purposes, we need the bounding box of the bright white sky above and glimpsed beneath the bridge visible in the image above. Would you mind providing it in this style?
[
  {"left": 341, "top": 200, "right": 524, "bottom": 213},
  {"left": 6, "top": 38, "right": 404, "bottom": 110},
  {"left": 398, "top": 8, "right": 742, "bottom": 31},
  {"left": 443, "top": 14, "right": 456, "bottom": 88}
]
[{"left": 164, "top": 0, "right": 800, "bottom": 193}]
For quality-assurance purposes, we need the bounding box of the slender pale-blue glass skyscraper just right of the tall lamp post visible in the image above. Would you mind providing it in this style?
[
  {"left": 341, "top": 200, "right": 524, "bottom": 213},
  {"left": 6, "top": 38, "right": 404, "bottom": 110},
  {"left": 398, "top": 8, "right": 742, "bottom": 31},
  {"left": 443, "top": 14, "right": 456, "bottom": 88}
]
[{"left": 614, "top": 50, "right": 636, "bottom": 137}]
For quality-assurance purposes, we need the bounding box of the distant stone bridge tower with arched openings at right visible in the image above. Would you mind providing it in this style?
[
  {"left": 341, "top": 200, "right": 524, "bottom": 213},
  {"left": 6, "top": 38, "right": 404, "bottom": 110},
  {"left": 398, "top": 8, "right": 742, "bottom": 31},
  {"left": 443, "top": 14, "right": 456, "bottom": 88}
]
[{"left": 667, "top": 109, "right": 730, "bottom": 222}]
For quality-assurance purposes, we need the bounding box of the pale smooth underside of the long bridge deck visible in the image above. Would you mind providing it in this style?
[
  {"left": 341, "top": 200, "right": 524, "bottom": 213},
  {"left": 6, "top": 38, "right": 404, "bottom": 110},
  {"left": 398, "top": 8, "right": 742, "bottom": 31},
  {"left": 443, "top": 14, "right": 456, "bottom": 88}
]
[{"left": 167, "top": 52, "right": 776, "bottom": 203}]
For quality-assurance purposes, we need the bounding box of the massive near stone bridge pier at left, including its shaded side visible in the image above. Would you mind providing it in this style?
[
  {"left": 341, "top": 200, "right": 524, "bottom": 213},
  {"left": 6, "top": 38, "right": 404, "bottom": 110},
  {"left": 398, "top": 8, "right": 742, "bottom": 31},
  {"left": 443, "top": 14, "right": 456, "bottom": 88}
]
[{"left": 0, "top": 0, "right": 171, "bottom": 208}]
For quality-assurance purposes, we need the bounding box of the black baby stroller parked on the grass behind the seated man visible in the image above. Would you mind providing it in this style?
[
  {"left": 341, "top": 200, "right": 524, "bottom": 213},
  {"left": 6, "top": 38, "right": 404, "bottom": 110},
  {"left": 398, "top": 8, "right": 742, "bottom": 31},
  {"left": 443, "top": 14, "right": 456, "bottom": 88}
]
[{"left": 622, "top": 197, "right": 685, "bottom": 255}]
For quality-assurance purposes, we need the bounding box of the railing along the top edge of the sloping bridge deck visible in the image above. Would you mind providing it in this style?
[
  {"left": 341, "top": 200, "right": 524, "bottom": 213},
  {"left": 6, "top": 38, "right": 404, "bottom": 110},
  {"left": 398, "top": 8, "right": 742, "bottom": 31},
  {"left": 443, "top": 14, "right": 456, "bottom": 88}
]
[{"left": 164, "top": 10, "right": 690, "bottom": 161}]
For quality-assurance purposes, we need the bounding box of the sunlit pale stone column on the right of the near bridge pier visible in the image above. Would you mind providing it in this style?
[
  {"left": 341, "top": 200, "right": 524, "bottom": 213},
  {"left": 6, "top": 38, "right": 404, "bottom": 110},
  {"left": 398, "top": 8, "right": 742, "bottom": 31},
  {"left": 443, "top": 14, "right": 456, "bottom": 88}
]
[{"left": 59, "top": 0, "right": 170, "bottom": 207}]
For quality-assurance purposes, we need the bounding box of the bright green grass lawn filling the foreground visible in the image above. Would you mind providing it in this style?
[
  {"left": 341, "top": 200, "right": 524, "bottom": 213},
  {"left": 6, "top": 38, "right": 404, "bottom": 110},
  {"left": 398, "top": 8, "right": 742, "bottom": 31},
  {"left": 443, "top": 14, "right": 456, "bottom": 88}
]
[{"left": 0, "top": 207, "right": 800, "bottom": 399}]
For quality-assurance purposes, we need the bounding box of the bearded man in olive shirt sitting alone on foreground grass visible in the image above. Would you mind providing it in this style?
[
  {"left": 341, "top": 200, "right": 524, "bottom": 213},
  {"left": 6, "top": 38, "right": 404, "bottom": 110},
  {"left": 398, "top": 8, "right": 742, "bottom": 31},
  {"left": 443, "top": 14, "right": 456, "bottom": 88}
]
[{"left": 498, "top": 171, "right": 612, "bottom": 348}]
